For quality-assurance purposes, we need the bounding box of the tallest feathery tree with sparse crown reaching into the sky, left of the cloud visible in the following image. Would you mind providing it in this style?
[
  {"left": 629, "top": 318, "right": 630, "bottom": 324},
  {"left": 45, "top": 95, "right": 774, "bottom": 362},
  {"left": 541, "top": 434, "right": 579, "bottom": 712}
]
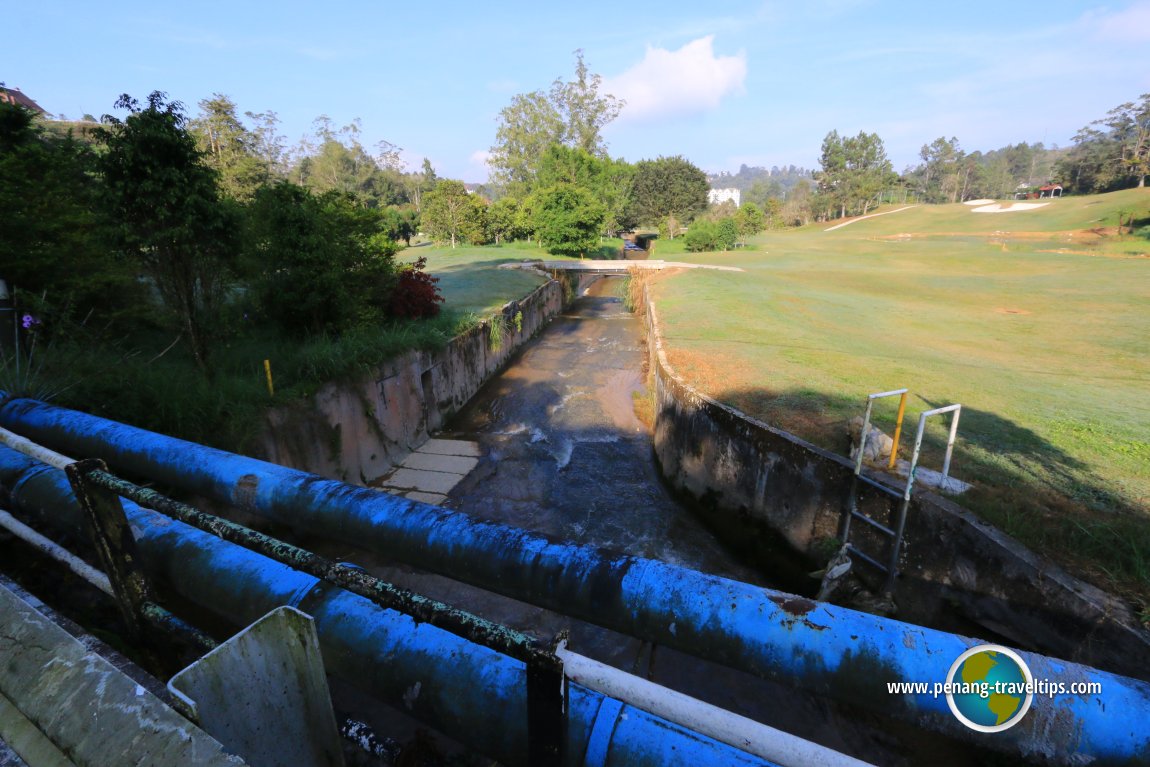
[{"left": 488, "top": 51, "right": 623, "bottom": 198}]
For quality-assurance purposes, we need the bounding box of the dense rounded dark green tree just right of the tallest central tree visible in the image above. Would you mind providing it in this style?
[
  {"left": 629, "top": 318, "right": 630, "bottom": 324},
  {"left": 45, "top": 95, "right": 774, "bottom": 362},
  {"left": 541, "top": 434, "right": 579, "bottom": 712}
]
[{"left": 631, "top": 155, "right": 711, "bottom": 238}]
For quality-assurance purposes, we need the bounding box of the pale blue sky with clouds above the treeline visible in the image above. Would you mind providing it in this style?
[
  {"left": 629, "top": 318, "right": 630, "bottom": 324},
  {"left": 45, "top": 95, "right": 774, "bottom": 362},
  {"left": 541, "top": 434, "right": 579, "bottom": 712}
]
[{"left": 8, "top": 0, "right": 1150, "bottom": 182}]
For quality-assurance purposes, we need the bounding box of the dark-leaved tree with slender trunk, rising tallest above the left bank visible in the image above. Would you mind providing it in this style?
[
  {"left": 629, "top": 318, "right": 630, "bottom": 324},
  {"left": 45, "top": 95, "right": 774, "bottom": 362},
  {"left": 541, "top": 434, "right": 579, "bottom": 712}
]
[{"left": 99, "top": 91, "right": 236, "bottom": 373}]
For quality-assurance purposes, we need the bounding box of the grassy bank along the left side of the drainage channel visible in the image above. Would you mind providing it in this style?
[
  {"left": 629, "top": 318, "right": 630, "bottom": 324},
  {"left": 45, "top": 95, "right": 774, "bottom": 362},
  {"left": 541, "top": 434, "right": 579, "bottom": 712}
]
[{"left": 13, "top": 246, "right": 552, "bottom": 451}]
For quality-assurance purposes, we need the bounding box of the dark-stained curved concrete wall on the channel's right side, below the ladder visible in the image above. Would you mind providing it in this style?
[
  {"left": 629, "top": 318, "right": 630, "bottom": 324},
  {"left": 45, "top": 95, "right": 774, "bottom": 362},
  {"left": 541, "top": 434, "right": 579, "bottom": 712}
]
[{"left": 647, "top": 300, "right": 1150, "bottom": 678}]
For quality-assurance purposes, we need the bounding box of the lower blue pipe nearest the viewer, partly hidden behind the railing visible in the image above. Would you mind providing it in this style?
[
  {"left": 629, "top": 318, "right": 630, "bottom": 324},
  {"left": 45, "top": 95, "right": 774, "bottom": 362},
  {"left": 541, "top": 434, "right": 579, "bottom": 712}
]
[{"left": 0, "top": 447, "right": 773, "bottom": 767}]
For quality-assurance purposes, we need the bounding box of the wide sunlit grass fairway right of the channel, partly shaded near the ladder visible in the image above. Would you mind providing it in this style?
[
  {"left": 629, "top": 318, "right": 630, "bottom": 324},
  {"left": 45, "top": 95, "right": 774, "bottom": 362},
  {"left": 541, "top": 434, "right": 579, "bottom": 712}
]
[{"left": 654, "top": 190, "right": 1150, "bottom": 604}]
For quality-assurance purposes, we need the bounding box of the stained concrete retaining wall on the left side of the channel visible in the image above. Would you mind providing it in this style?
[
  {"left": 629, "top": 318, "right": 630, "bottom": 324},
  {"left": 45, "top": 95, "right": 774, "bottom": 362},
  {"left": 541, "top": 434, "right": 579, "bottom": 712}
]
[{"left": 259, "top": 272, "right": 564, "bottom": 484}]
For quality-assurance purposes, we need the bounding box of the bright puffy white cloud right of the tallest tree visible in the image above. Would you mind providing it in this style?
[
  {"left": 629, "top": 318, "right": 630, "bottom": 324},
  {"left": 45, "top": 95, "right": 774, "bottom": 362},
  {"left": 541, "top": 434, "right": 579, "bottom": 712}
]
[{"left": 603, "top": 34, "right": 746, "bottom": 121}]
